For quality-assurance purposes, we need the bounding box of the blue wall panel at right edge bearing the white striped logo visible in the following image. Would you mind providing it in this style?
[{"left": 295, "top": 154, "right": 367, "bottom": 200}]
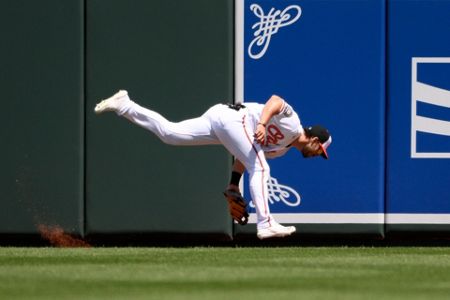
[{"left": 387, "top": 1, "right": 450, "bottom": 229}]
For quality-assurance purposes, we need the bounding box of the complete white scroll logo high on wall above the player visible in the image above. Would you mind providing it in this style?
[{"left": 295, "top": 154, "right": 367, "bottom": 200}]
[{"left": 248, "top": 4, "right": 302, "bottom": 59}]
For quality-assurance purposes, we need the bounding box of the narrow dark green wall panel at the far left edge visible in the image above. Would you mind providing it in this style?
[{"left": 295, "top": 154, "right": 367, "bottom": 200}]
[{"left": 0, "top": 0, "right": 84, "bottom": 234}]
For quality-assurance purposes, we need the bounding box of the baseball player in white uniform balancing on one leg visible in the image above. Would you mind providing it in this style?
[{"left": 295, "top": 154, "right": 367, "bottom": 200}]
[{"left": 95, "top": 90, "right": 331, "bottom": 239}]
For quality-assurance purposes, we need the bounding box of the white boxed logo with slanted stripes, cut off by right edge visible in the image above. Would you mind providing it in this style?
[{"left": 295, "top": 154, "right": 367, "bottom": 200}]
[{"left": 411, "top": 57, "right": 450, "bottom": 158}]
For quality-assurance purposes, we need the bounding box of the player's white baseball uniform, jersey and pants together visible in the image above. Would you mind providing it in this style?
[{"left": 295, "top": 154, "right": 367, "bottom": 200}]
[{"left": 117, "top": 97, "right": 303, "bottom": 229}]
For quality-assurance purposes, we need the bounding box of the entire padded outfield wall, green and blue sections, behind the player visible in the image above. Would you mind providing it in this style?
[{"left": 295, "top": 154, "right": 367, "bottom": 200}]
[{"left": 0, "top": 0, "right": 450, "bottom": 243}]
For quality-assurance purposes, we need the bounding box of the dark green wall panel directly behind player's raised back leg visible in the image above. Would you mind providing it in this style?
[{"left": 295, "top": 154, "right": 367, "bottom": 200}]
[{"left": 86, "top": 0, "right": 233, "bottom": 236}]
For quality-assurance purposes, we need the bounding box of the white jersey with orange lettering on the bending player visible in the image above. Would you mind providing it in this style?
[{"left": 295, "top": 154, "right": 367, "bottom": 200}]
[{"left": 244, "top": 101, "right": 303, "bottom": 158}]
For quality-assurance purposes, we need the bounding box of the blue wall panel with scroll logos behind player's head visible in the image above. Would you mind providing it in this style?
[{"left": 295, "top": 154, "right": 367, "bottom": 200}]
[{"left": 243, "top": 0, "right": 385, "bottom": 230}]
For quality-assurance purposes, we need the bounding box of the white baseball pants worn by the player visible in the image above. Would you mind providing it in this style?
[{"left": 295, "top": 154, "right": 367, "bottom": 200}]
[{"left": 117, "top": 101, "right": 274, "bottom": 229}]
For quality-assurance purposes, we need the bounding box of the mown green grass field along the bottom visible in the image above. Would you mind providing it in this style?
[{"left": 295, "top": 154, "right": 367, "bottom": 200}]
[{"left": 0, "top": 247, "right": 450, "bottom": 300}]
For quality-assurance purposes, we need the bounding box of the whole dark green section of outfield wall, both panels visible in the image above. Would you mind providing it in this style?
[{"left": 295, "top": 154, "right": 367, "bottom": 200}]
[{"left": 0, "top": 0, "right": 234, "bottom": 238}]
